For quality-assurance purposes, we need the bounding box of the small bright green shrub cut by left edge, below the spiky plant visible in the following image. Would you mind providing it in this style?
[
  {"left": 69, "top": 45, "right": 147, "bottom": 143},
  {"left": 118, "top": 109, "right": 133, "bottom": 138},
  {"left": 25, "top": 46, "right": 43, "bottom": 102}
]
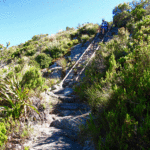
[{"left": 0, "top": 122, "right": 7, "bottom": 147}]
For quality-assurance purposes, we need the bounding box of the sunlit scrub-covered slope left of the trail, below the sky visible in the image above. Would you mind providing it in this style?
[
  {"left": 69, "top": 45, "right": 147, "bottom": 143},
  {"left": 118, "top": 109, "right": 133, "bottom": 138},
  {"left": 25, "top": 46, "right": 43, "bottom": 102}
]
[{"left": 0, "top": 23, "right": 98, "bottom": 149}]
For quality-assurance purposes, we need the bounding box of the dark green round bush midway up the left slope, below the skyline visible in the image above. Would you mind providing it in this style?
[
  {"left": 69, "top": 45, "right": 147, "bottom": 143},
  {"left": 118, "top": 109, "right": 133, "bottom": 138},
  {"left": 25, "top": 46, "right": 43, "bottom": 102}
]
[{"left": 36, "top": 53, "right": 52, "bottom": 68}]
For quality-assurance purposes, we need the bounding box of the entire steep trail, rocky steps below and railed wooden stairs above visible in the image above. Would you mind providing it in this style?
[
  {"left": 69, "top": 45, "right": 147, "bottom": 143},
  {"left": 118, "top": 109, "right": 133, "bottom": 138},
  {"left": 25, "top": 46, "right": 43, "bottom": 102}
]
[{"left": 24, "top": 25, "right": 118, "bottom": 150}]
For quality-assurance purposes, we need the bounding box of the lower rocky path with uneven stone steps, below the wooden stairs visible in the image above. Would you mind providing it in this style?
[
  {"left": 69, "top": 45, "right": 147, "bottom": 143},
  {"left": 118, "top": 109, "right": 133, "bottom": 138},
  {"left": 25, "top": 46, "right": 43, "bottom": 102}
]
[{"left": 24, "top": 88, "right": 94, "bottom": 150}]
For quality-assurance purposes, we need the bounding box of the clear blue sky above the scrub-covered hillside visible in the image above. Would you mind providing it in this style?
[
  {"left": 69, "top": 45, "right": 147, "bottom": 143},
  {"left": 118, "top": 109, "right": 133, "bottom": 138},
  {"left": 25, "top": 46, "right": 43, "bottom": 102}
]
[{"left": 0, "top": 0, "right": 132, "bottom": 46}]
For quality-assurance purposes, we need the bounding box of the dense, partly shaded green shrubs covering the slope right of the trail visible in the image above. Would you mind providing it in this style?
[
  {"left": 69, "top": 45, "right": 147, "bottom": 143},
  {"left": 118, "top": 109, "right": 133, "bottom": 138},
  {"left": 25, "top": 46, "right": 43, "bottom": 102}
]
[{"left": 75, "top": 0, "right": 150, "bottom": 150}]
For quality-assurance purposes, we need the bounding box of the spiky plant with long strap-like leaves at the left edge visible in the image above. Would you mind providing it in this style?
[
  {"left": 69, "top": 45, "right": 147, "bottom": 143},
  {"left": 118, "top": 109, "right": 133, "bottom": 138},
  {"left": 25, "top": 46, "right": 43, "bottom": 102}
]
[{"left": 0, "top": 76, "right": 39, "bottom": 119}]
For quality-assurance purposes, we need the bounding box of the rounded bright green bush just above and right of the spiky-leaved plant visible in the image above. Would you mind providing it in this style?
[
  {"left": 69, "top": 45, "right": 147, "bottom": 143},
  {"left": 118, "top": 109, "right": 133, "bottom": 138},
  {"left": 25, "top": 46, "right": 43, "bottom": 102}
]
[{"left": 21, "top": 67, "right": 44, "bottom": 89}]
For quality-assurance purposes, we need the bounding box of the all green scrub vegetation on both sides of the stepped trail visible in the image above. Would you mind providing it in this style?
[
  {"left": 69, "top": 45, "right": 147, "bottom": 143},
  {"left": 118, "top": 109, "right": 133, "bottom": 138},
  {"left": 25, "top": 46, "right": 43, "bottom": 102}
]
[{"left": 0, "top": 0, "right": 150, "bottom": 150}]
